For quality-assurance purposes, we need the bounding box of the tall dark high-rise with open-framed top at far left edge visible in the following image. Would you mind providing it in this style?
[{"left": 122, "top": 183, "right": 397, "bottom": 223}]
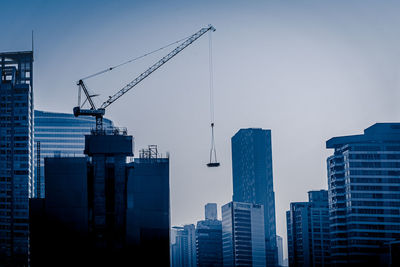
[{"left": 0, "top": 51, "right": 34, "bottom": 265}]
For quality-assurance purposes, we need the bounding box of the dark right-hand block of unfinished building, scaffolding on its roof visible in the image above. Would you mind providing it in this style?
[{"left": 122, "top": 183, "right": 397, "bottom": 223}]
[{"left": 126, "top": 149, "right": 170, "bottom": 266}]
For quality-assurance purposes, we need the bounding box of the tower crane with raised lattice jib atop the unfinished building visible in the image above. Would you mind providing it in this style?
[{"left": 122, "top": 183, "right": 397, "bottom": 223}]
[{"left": 73, "top": 25, "right": 215, "bottom": 134}]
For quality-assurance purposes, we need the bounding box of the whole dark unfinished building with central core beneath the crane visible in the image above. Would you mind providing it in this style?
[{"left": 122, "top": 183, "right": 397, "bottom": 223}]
[{"left": 30, "top": 128, "right": 169, "bottom": 266}]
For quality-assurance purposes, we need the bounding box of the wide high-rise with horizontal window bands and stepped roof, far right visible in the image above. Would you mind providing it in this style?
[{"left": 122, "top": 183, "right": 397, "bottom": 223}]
[{"left": 326, "top": 123, "right": 400, "bottom": 266}]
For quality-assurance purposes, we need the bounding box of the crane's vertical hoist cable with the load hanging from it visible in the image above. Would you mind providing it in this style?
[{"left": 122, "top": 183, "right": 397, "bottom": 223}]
[{"left": 207, "top": 29, "right": 220, "bottom": 167}]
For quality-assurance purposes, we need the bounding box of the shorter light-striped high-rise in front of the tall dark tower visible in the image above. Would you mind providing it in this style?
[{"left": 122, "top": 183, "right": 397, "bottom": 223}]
[{"left": 222, "top": 201, "right": 266, "bottom": 267}]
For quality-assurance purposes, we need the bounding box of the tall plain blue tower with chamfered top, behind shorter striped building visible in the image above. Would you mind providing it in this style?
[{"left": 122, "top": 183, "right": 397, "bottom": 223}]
[{"left": 232, "top": 128, "right": 278, "bottom": 266}]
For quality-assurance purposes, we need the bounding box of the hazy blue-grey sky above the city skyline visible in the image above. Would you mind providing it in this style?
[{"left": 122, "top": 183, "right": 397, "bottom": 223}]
[{"left": 0, "top": 0, "right": 400, "bottom": 260}]
